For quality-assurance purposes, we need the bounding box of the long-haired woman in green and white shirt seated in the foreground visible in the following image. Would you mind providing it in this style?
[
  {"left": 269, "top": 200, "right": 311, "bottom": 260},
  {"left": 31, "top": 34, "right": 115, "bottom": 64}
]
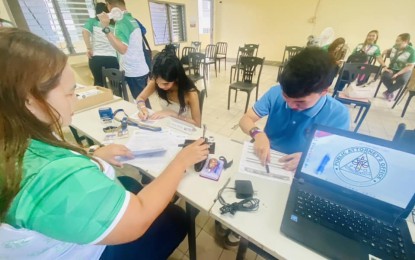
[{"left": 0, "top": 28, "right": 208, "bottom": 259}]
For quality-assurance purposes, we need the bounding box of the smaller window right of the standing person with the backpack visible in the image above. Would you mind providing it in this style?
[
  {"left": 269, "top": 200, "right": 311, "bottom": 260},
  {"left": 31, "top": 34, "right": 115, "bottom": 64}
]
[{"left": 149, "top": 2, "right": 186, "bottom": 45}]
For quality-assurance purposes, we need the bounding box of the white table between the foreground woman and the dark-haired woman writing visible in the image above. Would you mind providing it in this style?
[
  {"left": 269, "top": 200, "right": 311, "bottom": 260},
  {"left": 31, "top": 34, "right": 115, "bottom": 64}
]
[{"left": 71, "top": 100, "right": 242, "bottom": 259}]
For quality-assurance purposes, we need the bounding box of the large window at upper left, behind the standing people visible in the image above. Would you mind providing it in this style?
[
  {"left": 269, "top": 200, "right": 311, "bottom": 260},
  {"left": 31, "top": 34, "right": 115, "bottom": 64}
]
[{"left": 8, "top": 0, "right": 95, "bottom": 54}]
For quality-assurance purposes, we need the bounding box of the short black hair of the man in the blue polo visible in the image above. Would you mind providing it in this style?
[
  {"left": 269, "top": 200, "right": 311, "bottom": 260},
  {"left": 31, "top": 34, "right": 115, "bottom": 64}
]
[{"left": 280, "top": 47, "right": 335, "bottom": 98}]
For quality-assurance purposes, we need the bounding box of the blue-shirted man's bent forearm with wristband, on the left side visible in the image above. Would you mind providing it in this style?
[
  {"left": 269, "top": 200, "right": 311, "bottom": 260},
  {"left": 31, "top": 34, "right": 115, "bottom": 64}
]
[{"left": 239, "top": 108, "right": 270, "bottom": 165}]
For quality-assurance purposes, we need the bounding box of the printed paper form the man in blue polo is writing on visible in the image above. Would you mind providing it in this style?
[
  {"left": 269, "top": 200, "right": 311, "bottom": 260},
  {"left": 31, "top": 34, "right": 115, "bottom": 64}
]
[{"left": 239, "top": 142, "right": 293, "bottom": 183}]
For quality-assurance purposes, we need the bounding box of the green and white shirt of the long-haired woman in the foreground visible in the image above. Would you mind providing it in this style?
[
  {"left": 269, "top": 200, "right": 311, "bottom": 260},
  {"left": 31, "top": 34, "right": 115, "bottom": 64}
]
[{"left": 0, "top": 140, "right": 129, "bottom": 259}]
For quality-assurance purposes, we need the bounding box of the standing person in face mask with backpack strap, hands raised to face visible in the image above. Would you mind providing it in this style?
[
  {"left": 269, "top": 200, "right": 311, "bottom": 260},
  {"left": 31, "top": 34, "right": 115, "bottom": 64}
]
[{"left": 98, "top": 0, "right": 151, "bottom": 108}]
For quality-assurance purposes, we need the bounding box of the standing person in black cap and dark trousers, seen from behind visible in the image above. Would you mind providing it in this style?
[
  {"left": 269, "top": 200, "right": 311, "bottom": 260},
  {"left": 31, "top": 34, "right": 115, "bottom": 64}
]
[{"left": 82, "top": 3, "right": 120, "bottom": 87}]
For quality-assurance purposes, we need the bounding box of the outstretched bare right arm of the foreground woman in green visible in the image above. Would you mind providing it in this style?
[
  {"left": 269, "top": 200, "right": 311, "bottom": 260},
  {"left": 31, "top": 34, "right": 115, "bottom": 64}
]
[{"left": 99, "top": 139, "right": 209, "bottom": 245}]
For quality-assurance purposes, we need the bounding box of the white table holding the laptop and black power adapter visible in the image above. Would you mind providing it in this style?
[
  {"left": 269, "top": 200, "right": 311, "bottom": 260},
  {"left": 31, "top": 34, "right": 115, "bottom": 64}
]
[{"left": 211, "top": 173, "right": 322, "bottom": 259}]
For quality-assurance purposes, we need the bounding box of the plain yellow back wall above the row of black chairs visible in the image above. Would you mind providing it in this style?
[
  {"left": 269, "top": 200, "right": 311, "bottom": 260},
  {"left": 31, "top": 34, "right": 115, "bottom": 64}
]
[{"left": 214, "top": 0, "right": 415, "bottom": 61}]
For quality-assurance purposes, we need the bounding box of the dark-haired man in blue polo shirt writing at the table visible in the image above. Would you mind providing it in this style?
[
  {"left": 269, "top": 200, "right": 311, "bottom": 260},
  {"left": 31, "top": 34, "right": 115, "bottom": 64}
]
[{"left": 239, "top": 47, "right": 350, "bottom": 171}]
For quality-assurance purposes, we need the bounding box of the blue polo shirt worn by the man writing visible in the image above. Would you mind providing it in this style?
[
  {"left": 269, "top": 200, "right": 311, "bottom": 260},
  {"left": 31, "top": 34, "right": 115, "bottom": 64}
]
[{"left": 253, "top": 85, "right": 350, "bottom": 154}]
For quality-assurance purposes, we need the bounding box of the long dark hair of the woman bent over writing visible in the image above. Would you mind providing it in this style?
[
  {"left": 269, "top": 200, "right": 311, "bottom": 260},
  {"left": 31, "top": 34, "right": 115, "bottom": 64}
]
[{"left": 151, "top": 48, "right": 199, "bottom": 115}]
